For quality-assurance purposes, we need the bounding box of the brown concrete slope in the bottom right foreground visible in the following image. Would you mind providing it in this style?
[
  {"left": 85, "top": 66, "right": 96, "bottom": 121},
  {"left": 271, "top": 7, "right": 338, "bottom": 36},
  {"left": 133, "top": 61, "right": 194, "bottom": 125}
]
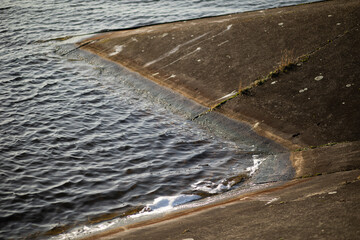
[{"left": 86, "top": 170, "right": 360, "bottom": 240}]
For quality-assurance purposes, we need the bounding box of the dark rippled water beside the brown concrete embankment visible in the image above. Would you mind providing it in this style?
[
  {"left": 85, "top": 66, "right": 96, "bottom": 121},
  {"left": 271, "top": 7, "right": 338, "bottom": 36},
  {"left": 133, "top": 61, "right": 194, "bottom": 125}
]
[{"left": 0, "top": 0, "right": 320, "bottom": 239}]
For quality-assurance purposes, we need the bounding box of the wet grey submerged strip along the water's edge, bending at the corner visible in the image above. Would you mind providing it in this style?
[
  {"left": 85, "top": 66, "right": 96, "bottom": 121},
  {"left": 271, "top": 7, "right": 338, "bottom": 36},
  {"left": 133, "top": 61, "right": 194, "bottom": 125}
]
[{"left": 52, "top": 43, "right": 294, "bottom": 239}]
